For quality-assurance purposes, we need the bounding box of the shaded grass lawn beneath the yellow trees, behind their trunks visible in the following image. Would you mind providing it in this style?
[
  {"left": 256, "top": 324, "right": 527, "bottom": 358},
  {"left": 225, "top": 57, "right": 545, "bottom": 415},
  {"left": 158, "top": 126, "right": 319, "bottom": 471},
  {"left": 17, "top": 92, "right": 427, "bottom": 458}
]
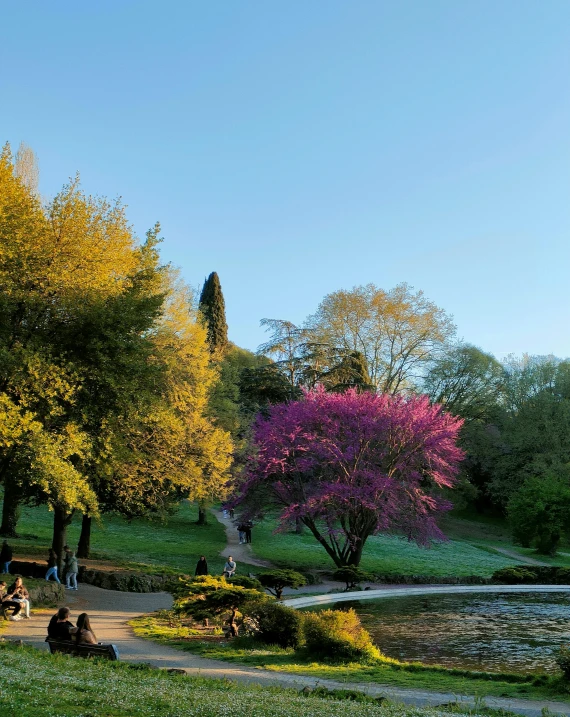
[{"left": 2, "top": 501, "right": 226, "bottom": 574}]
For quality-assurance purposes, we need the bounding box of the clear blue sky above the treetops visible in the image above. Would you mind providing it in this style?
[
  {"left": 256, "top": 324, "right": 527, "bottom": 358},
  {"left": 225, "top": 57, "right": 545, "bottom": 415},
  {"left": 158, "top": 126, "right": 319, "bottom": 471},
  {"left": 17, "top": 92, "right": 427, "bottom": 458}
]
[{"left": 0, "top": 0, "right": 570, "bottom": 357}]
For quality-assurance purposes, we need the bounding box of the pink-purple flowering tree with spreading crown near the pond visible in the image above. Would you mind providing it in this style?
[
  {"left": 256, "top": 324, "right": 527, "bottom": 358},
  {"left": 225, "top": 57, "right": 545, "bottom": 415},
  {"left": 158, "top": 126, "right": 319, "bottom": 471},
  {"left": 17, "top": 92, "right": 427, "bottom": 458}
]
[{"left": 238, "top": 388, "right": 463, "bottom": 567}]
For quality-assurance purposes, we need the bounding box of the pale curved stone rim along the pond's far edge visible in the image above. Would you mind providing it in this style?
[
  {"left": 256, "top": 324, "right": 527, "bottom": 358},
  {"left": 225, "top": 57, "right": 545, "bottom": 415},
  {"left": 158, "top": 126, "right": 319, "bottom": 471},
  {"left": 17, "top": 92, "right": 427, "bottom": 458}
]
[{"left": 281, "top": 585, "right": 570, "bottom": 608}]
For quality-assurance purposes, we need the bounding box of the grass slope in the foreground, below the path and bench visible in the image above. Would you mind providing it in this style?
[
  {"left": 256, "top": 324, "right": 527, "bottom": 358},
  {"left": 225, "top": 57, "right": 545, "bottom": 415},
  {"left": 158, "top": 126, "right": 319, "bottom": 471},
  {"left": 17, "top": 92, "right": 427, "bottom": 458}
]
[{"left": 0, "top": 644, "right": 506, "bottom": 717}]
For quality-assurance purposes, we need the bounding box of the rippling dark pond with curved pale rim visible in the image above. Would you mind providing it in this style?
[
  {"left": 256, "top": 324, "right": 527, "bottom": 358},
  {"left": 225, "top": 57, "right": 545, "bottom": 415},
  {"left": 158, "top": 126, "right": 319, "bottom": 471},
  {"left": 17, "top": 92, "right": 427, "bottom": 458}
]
[{"left": 326, "top": 593, "right": 570, "bottom": 672}]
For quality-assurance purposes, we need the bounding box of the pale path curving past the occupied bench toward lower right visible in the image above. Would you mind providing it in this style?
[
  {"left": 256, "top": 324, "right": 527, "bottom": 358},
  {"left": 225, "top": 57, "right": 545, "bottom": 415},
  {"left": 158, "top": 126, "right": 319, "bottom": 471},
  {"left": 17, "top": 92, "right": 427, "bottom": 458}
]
[{"left": 3, "top": 585, "right": 570, "bottom": 717}]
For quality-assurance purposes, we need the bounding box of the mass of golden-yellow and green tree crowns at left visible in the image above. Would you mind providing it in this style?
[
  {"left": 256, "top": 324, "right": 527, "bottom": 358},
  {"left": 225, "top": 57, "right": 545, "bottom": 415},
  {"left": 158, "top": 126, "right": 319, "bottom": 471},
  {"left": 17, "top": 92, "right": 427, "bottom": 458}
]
[{"left": 0, "top": 148, "right": 231, "bottom": 554}]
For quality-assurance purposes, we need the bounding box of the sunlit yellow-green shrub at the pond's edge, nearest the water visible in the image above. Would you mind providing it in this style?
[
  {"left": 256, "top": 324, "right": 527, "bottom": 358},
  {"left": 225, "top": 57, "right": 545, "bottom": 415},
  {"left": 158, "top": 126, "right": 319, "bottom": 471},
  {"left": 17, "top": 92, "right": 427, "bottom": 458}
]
[{"left": 303, "top": 610, "right": 380, "bottom": 660}]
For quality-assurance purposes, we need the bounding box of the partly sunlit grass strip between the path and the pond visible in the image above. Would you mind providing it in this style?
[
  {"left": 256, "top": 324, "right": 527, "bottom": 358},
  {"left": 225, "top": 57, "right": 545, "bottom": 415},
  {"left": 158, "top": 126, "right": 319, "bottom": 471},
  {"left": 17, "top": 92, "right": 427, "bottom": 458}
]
[{"left": 130, "top": 613, "right": 569, "bottom": 700}]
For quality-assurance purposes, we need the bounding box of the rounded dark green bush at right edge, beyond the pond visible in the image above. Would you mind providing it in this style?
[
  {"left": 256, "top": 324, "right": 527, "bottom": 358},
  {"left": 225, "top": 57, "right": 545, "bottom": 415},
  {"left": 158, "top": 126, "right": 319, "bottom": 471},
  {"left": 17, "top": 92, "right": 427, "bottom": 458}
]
[{"left": 508, "top": 469, "right": 570, "bottom": 555}]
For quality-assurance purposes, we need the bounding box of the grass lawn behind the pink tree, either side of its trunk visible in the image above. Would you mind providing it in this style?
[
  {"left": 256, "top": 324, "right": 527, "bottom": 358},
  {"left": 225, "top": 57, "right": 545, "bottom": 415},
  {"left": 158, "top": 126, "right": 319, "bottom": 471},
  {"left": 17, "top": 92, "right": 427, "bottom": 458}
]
[{"left": 252, "top": 518, "right": 518, "bottom": 577}]
